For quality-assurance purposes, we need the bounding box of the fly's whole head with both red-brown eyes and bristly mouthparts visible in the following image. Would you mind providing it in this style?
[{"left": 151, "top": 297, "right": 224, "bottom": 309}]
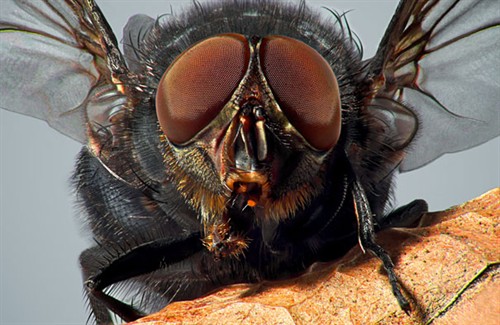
[{"left": 156, "top": 34, "right": 341, "bottom": 256}]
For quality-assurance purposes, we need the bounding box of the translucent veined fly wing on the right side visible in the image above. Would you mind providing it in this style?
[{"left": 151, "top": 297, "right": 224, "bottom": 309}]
[{"left": 367, "top": 0, "right": 500, "bottom": 171}]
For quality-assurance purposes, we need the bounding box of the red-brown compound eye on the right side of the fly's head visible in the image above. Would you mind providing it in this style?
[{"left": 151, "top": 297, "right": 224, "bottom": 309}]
[{"left": 259, "top": 36, "right": 341, "bottom": 150}]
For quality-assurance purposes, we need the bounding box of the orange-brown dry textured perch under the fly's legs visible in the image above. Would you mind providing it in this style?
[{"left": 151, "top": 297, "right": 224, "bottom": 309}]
[{"left": 133, "top": 188, "right": 500, "bottom": 324}]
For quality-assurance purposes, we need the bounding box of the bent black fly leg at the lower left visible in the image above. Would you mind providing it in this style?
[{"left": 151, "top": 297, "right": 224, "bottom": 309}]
[{"left": 80, "top": 233, "right": 203, "bottom": 324}]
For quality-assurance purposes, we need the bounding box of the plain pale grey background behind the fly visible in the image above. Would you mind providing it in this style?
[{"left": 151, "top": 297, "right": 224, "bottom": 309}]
[{"left": 0, "top": 0, "right": 500, "bottom": 324}]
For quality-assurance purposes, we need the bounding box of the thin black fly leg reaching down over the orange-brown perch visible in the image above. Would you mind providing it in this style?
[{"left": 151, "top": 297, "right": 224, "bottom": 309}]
[{"left": 352, "top": 180, "right": 410, "bottom": 313}]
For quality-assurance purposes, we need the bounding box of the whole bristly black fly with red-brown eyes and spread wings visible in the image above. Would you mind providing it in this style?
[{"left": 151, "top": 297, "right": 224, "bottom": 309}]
[{"left": 1, "top": 0, "right": 500, "bottom": 323}]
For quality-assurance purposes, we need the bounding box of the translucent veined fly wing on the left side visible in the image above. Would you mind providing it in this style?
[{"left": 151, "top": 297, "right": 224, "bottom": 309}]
[{"left": 0, "top": 0, "right": 128, "bottom": 143}]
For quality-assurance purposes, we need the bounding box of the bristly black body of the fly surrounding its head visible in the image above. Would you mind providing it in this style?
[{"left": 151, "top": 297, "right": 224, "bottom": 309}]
[{"left": 75, "top": 2, "right": 376, "bottom": 318}]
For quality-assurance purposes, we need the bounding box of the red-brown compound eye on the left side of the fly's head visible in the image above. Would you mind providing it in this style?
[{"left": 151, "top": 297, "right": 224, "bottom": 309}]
[{"left": 156, "top": 34, "right": 250, "bottom": 144}]
